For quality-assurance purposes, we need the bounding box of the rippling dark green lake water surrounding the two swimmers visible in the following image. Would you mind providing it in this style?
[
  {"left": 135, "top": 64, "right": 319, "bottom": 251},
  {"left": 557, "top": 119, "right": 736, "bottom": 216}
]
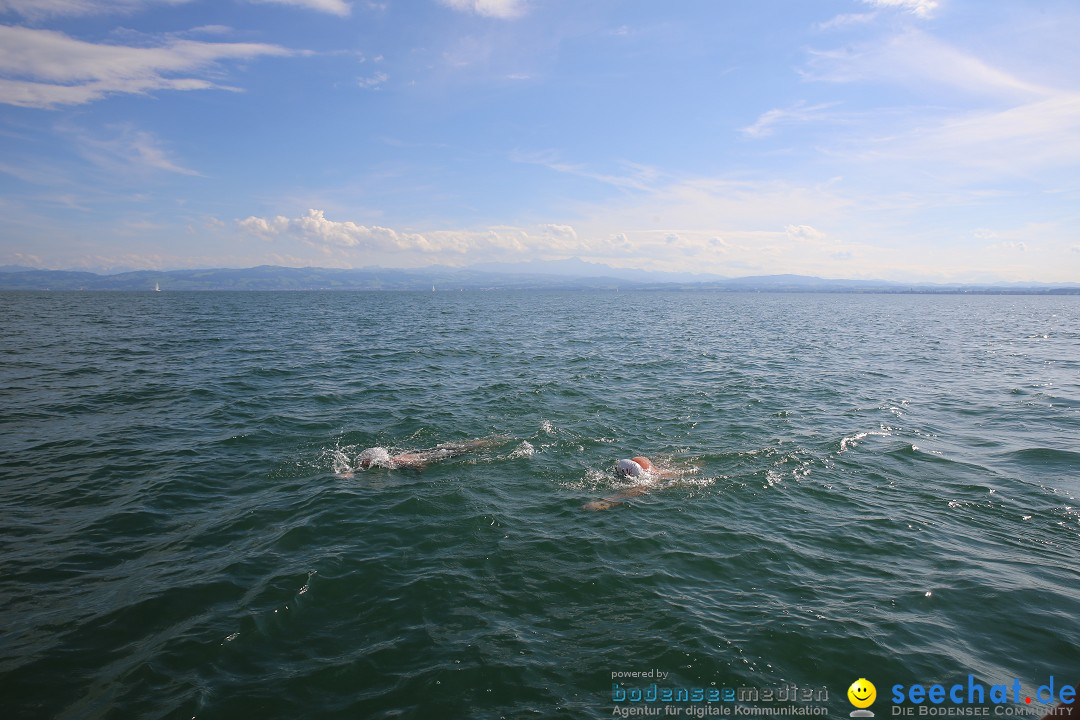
[{"left": 0, "top": 291, "right": 1080, "bottom": 719}]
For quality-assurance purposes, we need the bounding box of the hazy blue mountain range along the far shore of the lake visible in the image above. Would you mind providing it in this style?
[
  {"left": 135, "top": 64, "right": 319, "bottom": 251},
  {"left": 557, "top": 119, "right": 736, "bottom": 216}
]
[{"left": 0, "top": 263, "right": 1080, "bottom": 295}]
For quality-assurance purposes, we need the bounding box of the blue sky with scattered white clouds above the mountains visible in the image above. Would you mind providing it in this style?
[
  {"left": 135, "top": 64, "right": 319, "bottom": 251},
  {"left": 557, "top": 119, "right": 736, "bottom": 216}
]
[{"left": 0, "top": 0, "right": 1080, "bottom": 283}]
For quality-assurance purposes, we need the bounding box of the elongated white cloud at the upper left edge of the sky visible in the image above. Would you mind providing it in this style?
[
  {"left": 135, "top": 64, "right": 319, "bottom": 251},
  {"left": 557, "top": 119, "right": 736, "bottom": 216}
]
[{"left": 0, "top": 26, "right": 293, "bottom": 108}]
